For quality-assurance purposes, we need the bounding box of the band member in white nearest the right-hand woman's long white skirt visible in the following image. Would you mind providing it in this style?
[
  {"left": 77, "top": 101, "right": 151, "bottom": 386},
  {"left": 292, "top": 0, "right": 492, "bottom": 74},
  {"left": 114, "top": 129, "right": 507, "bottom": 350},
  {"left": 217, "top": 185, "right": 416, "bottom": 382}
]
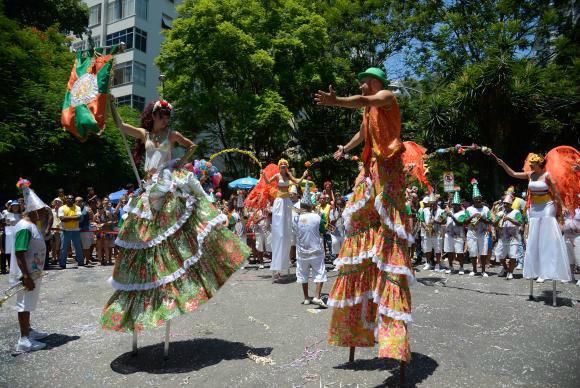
[{"left": 494, "top": 194, "right": 523, "bottom": 280}]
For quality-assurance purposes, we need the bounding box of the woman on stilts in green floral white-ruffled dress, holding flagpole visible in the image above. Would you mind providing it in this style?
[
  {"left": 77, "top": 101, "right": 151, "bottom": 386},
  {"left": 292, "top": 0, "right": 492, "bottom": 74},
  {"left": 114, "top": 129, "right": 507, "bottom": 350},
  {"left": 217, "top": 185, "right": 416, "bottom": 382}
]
[{"left": 101, "top": 100, "right": 249, "bottom": 332}]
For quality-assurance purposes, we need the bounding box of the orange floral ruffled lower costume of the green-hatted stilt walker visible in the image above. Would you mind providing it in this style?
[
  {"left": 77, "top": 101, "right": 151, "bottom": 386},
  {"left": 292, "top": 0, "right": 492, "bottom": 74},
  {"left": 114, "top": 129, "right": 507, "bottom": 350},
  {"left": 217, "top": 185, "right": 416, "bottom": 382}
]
[{"left": 328, "top": 154, "right": 415, "bottom": 361}]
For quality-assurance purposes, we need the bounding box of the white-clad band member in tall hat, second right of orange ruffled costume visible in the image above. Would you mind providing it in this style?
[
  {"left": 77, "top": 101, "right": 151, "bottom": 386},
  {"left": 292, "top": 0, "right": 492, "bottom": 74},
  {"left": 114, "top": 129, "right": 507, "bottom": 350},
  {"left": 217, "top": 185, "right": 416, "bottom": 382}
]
[{"left": 443, "top": 191, "right": 467, "bottom": 275}]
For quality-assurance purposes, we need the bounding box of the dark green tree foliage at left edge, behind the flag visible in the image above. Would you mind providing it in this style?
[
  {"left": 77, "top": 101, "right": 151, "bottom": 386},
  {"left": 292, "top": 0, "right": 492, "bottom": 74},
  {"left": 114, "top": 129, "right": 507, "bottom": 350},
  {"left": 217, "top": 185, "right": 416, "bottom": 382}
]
[{"left": 0, "top": 6, "right": 138, "bottom": 200}]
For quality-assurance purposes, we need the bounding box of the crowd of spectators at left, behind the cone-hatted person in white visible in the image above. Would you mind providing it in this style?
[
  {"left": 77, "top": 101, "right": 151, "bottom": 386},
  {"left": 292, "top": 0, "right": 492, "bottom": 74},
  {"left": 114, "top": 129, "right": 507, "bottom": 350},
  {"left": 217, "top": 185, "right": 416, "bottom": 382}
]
[{"left": 0, "top": 184, "right": 134, "bottom": 274}]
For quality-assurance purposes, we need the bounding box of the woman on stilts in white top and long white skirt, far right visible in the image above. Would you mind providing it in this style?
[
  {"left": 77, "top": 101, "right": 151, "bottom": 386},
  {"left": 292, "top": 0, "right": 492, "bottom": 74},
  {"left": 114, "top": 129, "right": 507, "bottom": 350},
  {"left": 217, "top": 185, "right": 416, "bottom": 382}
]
[{"left": 494, "top": 154, "right": 572, "bottom": 290}]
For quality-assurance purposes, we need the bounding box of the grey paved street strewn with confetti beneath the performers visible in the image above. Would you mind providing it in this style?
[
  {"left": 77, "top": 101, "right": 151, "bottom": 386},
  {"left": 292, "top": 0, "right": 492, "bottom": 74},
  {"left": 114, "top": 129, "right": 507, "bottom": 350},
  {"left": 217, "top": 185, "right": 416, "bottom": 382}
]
[{"left": 0, "top": 260, "right": 580, "bottom": 388}]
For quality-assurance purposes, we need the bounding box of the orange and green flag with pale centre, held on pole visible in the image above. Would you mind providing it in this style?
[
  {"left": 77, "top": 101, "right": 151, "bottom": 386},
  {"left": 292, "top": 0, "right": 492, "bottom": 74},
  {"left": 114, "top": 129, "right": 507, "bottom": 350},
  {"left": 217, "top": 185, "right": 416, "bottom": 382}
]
[{"left": 60, "top": 46, "right": 117, "bottom": 141}]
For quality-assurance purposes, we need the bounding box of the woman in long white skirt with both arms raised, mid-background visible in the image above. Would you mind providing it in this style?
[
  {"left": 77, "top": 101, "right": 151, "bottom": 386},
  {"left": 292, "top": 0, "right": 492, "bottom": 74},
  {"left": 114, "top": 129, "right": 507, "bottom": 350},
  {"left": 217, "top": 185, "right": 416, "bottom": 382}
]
[{"left": 262, "top": 159, "right": 308, "bottom": 282}]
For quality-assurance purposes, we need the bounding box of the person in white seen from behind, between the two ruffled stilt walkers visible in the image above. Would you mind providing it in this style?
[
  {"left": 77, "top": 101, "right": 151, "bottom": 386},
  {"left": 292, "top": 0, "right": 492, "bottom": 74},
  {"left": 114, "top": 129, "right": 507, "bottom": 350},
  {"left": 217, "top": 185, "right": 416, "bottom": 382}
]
[{"left": 292, "top": 200, "right": 327, "bottom": 307}]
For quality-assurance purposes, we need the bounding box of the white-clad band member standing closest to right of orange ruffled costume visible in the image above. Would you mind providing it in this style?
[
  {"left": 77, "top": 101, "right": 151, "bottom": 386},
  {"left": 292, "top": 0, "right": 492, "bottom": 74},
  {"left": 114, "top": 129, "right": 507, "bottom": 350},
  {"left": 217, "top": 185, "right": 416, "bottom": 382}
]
[{"left": 420, "top": 193, "right": 446, "bottom": 272}]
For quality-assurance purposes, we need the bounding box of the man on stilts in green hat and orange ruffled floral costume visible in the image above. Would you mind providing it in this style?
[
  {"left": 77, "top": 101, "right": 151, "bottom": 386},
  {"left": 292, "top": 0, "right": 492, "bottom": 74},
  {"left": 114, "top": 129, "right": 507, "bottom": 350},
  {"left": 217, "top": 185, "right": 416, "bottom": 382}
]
[{"left": 315, "top": 68, "right": 415, "bottom": 382}]
